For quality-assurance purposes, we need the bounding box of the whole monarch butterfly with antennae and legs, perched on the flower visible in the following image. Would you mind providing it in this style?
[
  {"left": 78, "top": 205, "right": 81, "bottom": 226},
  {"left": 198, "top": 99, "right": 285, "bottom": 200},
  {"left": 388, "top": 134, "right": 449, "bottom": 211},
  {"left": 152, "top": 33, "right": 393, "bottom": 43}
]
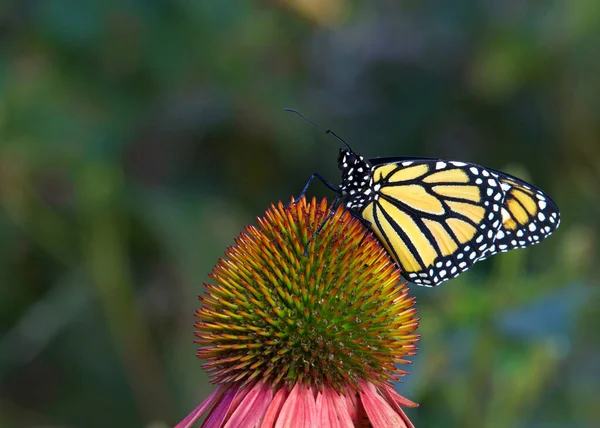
[{"left": 285, "top": 109, "right": 560, "bottom": 286}]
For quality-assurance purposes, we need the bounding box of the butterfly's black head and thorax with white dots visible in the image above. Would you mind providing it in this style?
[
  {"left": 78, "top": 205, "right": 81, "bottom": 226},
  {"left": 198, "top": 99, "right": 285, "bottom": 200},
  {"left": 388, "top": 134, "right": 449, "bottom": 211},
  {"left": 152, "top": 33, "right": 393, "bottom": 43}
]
[{"left": 338, "top": 149, "right": 374, "bottom": 211}]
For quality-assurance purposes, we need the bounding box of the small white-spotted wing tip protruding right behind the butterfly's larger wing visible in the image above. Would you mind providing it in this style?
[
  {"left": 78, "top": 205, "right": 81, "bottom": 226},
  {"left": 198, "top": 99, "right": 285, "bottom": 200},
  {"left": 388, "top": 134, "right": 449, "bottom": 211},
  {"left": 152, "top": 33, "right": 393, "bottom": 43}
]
[{"left": 480, "top": 170, "right": 560, "bottom": 260}]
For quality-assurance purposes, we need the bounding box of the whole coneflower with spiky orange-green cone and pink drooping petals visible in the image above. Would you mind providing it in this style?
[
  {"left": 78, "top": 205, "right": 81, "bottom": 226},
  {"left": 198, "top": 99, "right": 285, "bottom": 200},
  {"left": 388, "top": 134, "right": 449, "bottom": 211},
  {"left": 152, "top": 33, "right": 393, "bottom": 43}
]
[{"left": 177, "top": 198, "right": 418, "bottom": 428}]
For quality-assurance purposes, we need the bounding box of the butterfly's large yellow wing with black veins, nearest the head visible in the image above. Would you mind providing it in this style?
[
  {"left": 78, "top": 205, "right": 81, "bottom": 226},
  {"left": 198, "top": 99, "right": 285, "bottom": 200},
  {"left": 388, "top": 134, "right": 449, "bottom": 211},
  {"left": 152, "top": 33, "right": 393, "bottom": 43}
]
[{"left": 360, "top": 158, "right": 505, "bottom": 286}]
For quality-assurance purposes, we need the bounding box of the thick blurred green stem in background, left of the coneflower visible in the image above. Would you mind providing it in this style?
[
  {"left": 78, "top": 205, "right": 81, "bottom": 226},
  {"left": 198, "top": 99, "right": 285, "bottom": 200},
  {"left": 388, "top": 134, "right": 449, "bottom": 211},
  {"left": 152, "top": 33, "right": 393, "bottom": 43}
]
[{"left": 79, "top": 164, "right": 171, "bottom": 421}]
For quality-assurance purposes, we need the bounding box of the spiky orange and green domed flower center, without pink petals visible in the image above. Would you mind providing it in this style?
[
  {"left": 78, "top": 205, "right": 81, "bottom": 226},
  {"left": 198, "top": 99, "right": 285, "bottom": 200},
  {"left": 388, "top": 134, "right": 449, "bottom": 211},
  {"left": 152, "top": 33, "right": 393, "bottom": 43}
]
[{"left": 195, "top": 199, "right": 418, "bottom": 389}]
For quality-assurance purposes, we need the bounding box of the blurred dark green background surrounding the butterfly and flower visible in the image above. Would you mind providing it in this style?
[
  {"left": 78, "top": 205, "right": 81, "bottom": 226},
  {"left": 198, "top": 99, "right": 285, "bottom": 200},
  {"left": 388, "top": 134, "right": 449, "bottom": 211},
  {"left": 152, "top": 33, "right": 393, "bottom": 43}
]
[{"left": 0, "top": 0, "right": 600, "bottom": 428}]
